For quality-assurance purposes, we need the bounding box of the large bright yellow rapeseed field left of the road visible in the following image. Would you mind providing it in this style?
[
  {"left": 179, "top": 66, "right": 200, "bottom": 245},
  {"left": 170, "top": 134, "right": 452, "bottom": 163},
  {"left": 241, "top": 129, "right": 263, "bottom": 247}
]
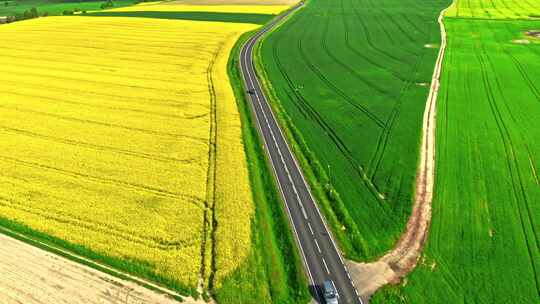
[{"left": 0, "top": 5, "right": 281, "bottom": 288}]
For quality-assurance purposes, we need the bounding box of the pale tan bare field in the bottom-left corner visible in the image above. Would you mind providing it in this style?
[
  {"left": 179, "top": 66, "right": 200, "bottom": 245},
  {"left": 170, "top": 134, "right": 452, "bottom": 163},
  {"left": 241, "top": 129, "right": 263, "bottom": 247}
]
[{"left": 0, "top": 234, "right": 204, "bottom": 304}]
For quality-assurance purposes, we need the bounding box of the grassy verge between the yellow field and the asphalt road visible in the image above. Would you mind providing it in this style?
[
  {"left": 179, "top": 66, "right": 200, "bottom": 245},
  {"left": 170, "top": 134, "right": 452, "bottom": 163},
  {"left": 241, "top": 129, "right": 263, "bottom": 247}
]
[{"left": 214, "top": 27, "right": 309, "bottom": 303}]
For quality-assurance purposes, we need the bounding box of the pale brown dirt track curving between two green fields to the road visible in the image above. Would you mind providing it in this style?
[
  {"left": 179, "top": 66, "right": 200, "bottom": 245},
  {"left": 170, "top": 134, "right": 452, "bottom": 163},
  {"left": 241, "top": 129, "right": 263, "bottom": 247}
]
[{"left": 347, "top": 5, "right": 446, "bottom": 300}]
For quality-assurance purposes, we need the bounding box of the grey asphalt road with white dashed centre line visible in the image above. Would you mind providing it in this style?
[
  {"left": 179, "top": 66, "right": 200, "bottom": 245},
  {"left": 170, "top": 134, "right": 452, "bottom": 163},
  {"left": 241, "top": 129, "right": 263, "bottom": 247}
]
[{"left": 240, "top": 3, "right": 362, "bottom": 303}]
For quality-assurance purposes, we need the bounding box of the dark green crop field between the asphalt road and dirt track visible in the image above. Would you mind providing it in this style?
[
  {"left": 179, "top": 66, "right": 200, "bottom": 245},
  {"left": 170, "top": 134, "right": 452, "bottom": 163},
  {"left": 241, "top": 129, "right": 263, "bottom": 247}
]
[{"left": 260, "top": 0, "right": 450, "bottom": 260}]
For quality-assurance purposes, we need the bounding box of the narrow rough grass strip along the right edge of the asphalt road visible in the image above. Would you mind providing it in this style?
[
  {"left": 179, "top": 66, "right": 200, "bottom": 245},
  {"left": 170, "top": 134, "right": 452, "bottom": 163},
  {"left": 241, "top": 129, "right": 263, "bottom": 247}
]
[{"left": 254, "top": 1, "right": 364, "bottom": 260}]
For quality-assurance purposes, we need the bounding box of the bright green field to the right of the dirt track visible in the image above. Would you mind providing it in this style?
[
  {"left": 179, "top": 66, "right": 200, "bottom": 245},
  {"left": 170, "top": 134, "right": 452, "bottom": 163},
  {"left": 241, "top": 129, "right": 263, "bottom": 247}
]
[{"left": 372, "top": 7, "right": 540, "bottom": 304}]
